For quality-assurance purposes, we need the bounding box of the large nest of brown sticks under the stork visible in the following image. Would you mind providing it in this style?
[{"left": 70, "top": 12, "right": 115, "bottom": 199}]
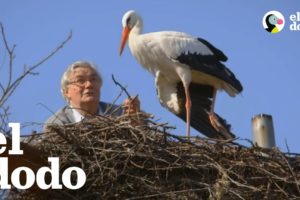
[{"left": 11, "top": 114, "right": 300, "bottom": 199}]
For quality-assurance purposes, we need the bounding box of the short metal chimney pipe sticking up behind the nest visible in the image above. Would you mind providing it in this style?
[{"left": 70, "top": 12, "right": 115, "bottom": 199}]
[{"left": 252, "top": 114, "right": 276, "bottom": 148}]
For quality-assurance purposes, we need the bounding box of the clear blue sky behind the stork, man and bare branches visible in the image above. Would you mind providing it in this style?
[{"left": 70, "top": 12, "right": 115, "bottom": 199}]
[{"left": 0, "top": 0, "right": 300, "bottom": 152}]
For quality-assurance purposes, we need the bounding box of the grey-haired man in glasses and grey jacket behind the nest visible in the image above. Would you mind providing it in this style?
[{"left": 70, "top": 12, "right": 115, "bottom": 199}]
[{"left": 45, "top": 61, "right": 140, "bottom": 127}]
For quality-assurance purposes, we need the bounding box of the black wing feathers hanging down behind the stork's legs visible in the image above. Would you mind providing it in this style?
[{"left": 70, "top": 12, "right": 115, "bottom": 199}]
[{"left": 177, "top": 82, "right": 235, "bottom": 139}]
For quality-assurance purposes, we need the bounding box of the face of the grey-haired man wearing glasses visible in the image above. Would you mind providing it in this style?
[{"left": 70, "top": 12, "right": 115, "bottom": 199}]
[{"left": 65, "top": 67, "right": 102, "bottom": 108}]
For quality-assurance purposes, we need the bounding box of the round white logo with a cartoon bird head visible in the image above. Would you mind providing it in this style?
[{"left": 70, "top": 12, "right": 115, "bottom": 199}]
[{"left": 262, "top": 11, "right": 285, "bottom": 33}]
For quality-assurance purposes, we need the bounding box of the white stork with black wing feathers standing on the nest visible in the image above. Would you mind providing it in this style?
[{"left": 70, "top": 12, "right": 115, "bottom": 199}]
[{"left": 120, "top": 10, "right": 243, "bottom": 139}]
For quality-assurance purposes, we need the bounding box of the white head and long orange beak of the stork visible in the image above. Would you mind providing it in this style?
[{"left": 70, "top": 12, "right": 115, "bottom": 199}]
[{"left": 120, "top": 10, "right": 142, "bottom": 55}]
